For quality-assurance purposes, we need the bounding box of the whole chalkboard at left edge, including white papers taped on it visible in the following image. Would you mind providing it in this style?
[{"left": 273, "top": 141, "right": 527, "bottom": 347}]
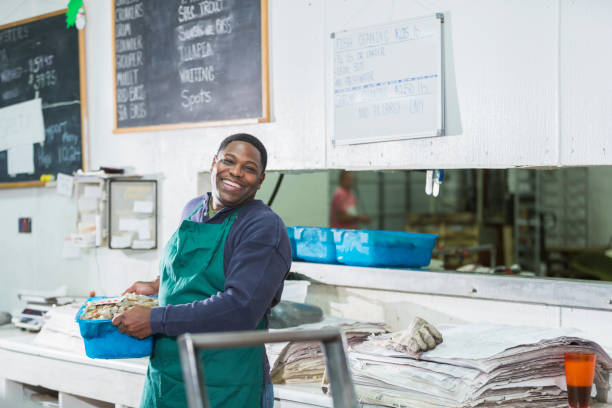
[{"left": 0, "top": 10, "right": 86, "bottom": 188}]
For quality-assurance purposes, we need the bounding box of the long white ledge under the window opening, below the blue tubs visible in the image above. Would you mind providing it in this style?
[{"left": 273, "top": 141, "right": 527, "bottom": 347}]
[{"left": 291, "top": 262, "right": 612, "bottom": 311}]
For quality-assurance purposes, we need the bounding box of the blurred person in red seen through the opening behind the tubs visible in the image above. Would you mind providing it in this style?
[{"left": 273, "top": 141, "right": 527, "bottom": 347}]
[{"left": 329, "top": 170, "right": 370, "bottom": 229}]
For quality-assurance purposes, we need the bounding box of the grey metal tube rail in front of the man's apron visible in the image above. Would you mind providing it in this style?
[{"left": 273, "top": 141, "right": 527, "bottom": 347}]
[{"left": 177, "top": 328, "right": 359, "bottom": 408}]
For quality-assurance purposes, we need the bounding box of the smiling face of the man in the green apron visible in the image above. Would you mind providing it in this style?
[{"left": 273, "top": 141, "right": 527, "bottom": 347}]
[{"left": 210, "top": 141, "right": 266, "bottom": 209}]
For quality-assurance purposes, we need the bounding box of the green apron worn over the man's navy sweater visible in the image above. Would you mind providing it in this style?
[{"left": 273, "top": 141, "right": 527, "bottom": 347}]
[{"left": 140, "top": 204, "right": 265, "bottom": 408}]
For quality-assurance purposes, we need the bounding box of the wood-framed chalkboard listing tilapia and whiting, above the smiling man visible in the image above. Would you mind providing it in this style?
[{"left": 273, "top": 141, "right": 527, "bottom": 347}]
[{"left": 113, "top": 0, "right": 269, "bottom": 132}]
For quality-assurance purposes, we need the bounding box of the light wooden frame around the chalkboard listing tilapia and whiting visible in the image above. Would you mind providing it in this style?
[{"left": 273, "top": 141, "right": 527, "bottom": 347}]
[{"left": 111, "top": 0, "right": 270, "bottom": 133}]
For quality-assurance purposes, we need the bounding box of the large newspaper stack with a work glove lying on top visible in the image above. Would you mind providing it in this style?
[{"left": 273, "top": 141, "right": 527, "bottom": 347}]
[{"left": 349, "top": 323, "right": 612, "bottom": 408}]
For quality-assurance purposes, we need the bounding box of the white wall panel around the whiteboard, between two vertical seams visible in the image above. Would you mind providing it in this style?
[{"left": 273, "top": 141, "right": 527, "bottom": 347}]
[{"left": 326, "top": 0, "right": 559, "bottom": 168}]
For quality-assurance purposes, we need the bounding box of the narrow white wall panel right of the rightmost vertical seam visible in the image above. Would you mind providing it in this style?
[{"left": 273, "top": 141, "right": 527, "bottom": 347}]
[{"left": 560, "top": 0, "right": 612, "bottom": 166}]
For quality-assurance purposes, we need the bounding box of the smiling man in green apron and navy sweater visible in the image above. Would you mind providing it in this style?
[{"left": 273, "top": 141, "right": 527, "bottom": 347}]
[{"left": 113, "top": 134, "right": 291, "bottom": 408}]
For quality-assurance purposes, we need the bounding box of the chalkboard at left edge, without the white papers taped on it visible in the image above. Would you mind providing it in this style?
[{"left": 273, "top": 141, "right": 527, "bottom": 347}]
[{"left": 0, "top": 10, "right": 85, "bottom": 188}]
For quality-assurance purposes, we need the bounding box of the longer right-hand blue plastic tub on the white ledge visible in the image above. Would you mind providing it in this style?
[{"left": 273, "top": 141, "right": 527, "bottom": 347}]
[{"left": 333, "top": 229, "right": 438, "bottom": 267}]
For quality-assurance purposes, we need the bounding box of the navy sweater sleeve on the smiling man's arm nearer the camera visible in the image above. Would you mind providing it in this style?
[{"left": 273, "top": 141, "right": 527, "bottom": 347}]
[{"left": 151, "top": 213, "right": 291, "bottom": 336}]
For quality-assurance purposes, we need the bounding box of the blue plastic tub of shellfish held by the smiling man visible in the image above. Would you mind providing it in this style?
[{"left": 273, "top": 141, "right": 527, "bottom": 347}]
[{"left": 76, "top": 296, "right": 153, "bottom": 359}]
